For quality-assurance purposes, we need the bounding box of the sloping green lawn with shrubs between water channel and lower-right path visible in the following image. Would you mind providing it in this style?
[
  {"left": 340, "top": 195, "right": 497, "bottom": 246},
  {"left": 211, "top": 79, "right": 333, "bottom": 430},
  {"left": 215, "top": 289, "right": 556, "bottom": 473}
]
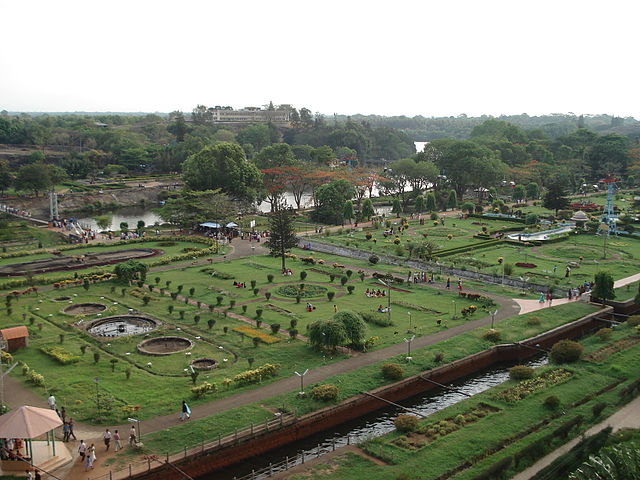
[{"left": 284, "top": 318, "right": 640, "bottom": 480}]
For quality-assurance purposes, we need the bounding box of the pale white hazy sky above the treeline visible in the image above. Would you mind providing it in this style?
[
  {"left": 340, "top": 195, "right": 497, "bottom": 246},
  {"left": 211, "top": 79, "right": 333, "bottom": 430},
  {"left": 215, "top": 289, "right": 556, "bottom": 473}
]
[{"left": 0, "top": 0, "right": 640, "bottom": 118}]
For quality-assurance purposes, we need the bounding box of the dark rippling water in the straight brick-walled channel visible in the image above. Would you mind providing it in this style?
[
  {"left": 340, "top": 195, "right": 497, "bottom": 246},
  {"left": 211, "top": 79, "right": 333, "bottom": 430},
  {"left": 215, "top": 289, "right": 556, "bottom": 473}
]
[{"left": 204, "top": 356, "right": 548, "bottom": 480}]
